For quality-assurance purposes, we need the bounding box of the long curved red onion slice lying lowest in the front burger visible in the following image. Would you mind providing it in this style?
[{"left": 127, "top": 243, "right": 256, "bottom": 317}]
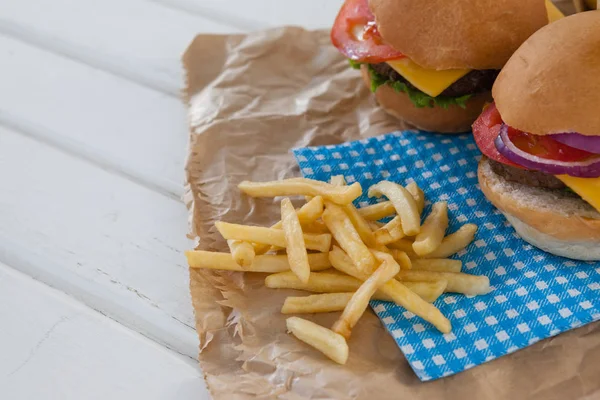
[{"left": 495, "top": 124, "right": 600, "bottom": 178}]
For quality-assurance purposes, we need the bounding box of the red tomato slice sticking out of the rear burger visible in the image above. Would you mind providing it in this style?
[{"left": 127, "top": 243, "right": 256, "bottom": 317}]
[{"left": 331, "top": 0, "right": 404, "bottom": 63}]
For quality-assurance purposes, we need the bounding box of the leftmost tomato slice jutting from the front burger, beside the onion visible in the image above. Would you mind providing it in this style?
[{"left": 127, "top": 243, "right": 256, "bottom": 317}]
[{"left": 473, "top": 103, "right": 523, "bottom": 168}]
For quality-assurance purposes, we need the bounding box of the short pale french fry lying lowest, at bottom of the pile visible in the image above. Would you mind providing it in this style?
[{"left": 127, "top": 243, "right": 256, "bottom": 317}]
[{"left": 285, "top": 317, "right": 348, "bottom": 364}]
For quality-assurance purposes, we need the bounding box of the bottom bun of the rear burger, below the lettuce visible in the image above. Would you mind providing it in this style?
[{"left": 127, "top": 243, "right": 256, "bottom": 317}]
[{"left": 361, "top": 66, "right": 492, "bottom": 133}]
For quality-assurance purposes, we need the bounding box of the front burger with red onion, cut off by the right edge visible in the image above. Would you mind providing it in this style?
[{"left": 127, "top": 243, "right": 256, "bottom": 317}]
[{"left": 473, "top": 11, "right": 600, "bottom": 260}]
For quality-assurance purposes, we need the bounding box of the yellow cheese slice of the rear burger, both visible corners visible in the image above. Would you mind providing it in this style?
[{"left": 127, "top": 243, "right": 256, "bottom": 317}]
[{"left": 387, "top": 0, "right": 564, "bottom": 97}]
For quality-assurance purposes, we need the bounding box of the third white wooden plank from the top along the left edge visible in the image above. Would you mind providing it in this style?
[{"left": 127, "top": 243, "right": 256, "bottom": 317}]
[{"left": 0, "top": 128, "right": 197, "bottom": 358}]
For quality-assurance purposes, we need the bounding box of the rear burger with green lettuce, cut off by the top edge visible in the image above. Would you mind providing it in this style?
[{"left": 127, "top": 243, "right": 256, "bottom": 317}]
[{"left": 331, "top": 0, "right": 563, "bottom": 133}]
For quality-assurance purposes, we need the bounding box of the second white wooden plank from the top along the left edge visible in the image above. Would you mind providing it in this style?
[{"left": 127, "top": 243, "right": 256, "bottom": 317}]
[{"left": 0, "top": 35, "right": 188, "bottom": 198}]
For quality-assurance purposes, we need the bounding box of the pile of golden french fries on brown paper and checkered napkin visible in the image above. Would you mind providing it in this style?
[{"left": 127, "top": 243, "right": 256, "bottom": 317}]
[{"left": 186, "top": 176, "right": 490, "bottom": 364}]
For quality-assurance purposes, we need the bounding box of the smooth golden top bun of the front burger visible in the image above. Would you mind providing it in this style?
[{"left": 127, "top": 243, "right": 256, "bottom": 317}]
[{"left": 492, "top": 11, "right": 600, "bottom": 136}]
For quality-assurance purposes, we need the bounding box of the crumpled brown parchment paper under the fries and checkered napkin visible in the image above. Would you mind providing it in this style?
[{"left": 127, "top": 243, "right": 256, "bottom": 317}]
[{"left": 184, "top": 3, "right": 600, "bottom": 400}]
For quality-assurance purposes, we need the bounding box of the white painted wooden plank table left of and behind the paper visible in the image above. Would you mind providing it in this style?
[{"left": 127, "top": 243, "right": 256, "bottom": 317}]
[{"left": 0, "top": 0, "right": 341, "bottom": 400}]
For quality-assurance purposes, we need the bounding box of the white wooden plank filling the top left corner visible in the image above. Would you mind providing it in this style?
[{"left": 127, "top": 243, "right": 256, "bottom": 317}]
[{"left": 0, "top": 0, "right": 239, "bottom": 96}]
